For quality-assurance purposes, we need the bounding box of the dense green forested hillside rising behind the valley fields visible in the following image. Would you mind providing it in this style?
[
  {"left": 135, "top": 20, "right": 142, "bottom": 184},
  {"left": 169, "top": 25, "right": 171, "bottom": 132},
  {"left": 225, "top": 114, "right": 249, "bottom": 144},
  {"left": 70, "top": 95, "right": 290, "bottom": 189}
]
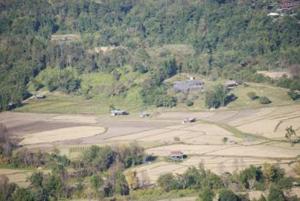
[{"left": 0, "top": 0, "right": 300, "bottom": 110}]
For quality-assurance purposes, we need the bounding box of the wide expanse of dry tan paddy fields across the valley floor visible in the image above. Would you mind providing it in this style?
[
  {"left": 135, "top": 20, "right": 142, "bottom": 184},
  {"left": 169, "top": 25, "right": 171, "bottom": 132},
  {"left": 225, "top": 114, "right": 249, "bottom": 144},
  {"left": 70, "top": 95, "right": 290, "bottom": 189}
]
[{"left": 0, "top": 104, "right": 300, "bottom": 183}]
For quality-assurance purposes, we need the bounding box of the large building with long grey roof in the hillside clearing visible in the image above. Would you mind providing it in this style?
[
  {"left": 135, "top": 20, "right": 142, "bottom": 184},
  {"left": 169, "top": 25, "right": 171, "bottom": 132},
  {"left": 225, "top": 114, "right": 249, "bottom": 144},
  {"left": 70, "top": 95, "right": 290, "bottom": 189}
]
[{"left": 173, "top": 80, "right": 204, "bottom": 92}]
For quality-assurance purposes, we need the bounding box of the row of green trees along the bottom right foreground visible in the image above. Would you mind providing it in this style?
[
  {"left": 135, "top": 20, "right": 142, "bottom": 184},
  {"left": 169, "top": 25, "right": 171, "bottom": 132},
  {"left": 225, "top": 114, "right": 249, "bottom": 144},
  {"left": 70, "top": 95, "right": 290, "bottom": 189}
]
[{"left": 157, "top": 164, "right": 297, "bottom": 201}]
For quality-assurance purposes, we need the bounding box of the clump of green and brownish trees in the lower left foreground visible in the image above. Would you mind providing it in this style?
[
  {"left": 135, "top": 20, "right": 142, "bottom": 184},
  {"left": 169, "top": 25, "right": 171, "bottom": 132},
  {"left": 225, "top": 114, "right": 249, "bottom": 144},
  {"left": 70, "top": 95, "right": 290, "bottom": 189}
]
[{"left": 0, "top": 144, "right": 147, "bottom": 201}]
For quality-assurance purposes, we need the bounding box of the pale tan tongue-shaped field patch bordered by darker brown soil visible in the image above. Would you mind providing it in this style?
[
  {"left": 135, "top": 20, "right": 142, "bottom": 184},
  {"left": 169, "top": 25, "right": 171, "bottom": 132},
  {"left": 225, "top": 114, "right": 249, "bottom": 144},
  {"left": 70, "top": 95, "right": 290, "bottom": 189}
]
[{"left": 20, "top": 126, "right": 105, "bottom": 145}]
